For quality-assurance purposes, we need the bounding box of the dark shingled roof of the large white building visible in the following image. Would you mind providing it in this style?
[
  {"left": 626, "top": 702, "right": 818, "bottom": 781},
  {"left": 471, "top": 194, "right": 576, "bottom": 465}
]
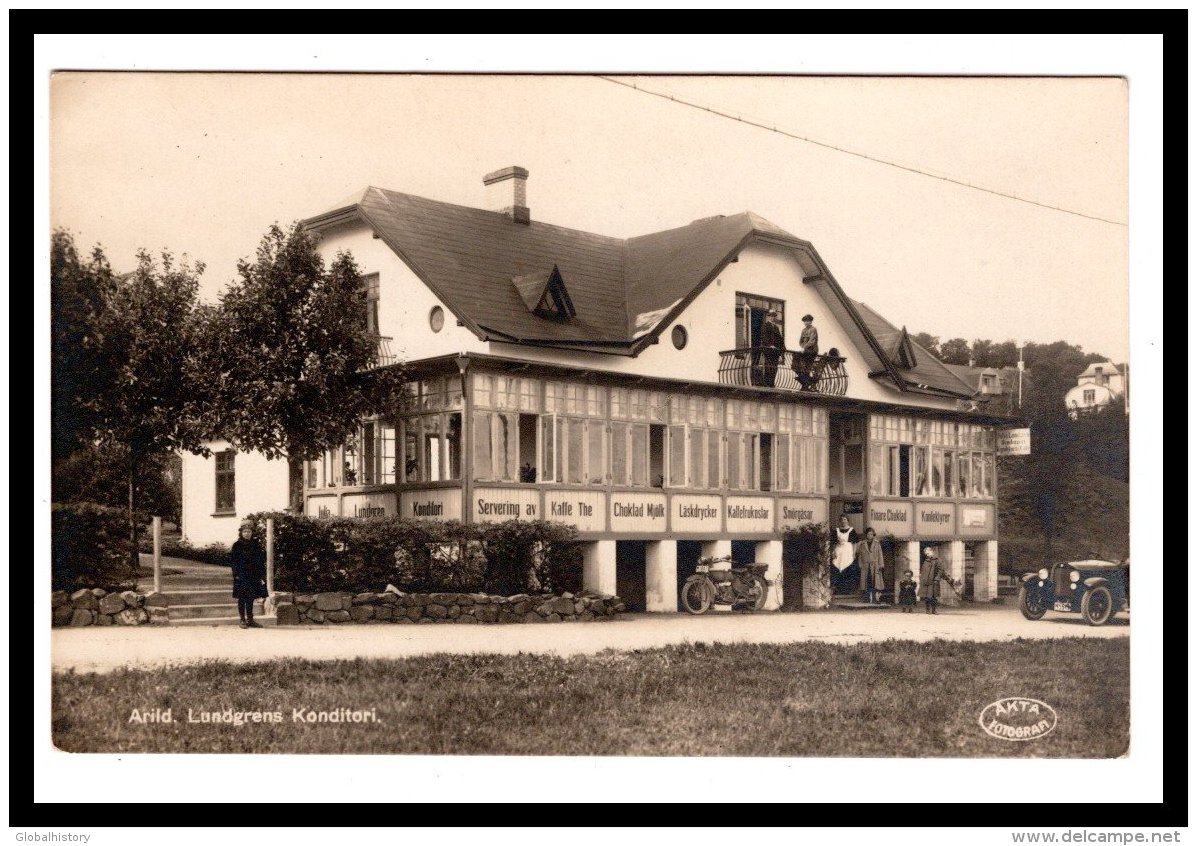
[{"left": 304, "top": 187, "right": 973, "bottom": 396}]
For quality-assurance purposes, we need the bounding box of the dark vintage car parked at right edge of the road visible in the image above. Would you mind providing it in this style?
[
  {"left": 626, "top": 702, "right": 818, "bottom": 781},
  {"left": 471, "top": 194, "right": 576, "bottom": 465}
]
[{"left": 1019, "top": 559, "right": 1130, "bottom": 626}]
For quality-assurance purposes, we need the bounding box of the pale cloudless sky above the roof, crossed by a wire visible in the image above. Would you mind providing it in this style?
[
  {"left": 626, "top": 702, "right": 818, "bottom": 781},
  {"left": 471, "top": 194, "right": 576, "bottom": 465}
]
[{"left": 49, "top": 72, "right": 1129, "bottom": 361}]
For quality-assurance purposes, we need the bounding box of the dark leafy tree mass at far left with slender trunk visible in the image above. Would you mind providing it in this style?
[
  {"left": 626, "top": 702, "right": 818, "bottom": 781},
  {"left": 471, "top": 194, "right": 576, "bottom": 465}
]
[{"left": 50, "top": 231, "right": 205, "bottom": 567}]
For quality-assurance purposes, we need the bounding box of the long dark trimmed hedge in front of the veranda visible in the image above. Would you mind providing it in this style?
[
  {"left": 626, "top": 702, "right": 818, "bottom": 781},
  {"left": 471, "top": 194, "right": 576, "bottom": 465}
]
[{"left": 242, "top": 512, "right": 582, "bottom": 594}]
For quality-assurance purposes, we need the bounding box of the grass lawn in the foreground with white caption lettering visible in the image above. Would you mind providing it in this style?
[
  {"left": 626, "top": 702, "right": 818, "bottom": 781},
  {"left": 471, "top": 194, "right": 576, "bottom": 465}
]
[{"left": 53, "top": 638, "right": 1129, "bottom": 757}]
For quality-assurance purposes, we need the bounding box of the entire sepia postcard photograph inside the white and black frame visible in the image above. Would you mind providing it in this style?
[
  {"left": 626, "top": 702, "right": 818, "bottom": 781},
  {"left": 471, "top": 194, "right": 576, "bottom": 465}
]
[{"left": 36, "top": 36, "right": 1163, "bottom": 824}]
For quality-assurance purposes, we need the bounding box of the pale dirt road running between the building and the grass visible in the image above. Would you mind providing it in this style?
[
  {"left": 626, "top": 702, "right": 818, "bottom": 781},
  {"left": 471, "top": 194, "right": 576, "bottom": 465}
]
[{"left": 51, "top": 603, "right": 1130, "bottom": 672}]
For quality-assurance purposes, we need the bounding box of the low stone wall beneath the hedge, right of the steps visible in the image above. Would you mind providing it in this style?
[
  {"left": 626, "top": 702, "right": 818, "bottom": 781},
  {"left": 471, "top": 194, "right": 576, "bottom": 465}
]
[{"left": 266, "top": 585, "right": 625, "bottom": 626}]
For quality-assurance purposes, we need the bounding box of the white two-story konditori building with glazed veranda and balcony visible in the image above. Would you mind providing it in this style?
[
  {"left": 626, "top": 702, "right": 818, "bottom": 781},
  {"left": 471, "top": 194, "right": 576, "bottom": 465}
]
[{"left": 184, "top": 168, "right": 1009, "bottom": 610}]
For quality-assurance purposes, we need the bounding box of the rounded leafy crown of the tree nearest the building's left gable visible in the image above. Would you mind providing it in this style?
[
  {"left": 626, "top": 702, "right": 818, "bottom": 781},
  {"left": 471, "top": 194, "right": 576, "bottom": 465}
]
[{"left": 200, "top": 224, "right": 403, "bottom": 507}]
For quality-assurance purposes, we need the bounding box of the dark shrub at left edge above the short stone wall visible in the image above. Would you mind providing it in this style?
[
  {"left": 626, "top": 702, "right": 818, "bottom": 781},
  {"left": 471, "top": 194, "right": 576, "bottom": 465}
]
[{"left": 50, "top": 503, "right": 136, "bottom": 591}]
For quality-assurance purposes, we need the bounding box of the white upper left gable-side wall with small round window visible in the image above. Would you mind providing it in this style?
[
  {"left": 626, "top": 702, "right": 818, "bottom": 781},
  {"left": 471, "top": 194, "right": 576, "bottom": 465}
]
[{"left": 320, "top": 223, "right": 486, "bottom": 361}]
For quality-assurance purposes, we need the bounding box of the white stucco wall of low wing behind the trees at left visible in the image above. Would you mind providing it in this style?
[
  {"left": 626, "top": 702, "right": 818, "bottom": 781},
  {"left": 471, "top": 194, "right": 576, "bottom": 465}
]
[{"left": 182, "top": 442, "right": 287, "bottom": 546}]
